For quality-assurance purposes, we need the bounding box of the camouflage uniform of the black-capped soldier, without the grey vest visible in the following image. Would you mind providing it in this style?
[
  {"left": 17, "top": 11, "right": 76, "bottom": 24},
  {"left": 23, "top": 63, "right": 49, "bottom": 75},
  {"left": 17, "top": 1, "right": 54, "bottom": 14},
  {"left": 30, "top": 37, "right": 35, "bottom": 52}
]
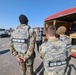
[{"left": 10, "top": 24, "right": 36, "bottom": 75}]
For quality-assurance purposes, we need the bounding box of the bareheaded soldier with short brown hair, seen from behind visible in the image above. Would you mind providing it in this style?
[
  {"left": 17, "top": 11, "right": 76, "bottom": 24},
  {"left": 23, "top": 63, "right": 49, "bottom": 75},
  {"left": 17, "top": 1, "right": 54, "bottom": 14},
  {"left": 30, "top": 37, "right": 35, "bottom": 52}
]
[{"left": 39, "top": 25, "right": 67, "bottom": 75}]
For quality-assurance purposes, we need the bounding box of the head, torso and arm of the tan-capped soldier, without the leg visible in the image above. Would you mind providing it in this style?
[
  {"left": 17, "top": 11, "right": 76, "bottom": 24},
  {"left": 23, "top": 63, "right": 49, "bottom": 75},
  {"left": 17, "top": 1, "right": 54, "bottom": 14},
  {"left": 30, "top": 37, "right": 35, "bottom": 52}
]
[{"left": 56, "top": 26, "right": 72, "bottom": 57}]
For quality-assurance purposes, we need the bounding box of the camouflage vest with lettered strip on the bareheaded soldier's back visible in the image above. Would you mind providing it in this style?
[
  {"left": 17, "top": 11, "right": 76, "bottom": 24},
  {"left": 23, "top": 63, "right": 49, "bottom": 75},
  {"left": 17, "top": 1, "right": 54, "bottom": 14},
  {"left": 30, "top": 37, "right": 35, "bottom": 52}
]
[{"left": 43, "top": 41, "right": 67, "bottom": 74}]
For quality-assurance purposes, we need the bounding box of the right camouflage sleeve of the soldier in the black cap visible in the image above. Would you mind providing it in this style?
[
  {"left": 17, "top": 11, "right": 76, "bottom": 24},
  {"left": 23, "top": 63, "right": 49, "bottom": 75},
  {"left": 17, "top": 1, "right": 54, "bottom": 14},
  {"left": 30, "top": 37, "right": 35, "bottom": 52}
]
[{"left": 24, "top": 31, "right": 36, "bottom": 59}]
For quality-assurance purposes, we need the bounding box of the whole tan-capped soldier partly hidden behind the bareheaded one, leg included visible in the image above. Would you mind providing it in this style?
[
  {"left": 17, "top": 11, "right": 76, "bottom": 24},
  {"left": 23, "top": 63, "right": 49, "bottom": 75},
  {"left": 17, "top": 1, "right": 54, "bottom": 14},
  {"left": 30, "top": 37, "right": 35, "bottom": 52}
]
[{"left": 57, "top": 26, "right": 72, "bottom": 73}]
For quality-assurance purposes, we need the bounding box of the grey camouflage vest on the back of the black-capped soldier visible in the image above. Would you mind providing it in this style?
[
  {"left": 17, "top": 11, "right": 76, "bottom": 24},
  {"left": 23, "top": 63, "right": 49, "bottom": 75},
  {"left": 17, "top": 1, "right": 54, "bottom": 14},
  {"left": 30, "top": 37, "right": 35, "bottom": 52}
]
[{"left": 12, "top": 25, "right": 30, "bottom": 53}]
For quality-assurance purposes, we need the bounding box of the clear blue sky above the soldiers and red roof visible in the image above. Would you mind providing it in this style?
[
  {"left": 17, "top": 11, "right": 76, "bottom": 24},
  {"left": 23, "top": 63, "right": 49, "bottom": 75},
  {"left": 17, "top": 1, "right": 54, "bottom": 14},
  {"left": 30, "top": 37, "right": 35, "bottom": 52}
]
[{"left": 0, "top": 0, "right": 76, "bottom": 29}]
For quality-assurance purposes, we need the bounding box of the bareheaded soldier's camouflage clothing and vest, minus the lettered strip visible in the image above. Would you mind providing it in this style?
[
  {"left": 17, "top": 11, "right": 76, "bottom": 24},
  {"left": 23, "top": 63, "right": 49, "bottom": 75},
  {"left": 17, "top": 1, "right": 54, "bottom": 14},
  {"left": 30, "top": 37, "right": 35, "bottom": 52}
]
[{"left": 40, "top": 39, "right": 67, "bottom": 75}]
